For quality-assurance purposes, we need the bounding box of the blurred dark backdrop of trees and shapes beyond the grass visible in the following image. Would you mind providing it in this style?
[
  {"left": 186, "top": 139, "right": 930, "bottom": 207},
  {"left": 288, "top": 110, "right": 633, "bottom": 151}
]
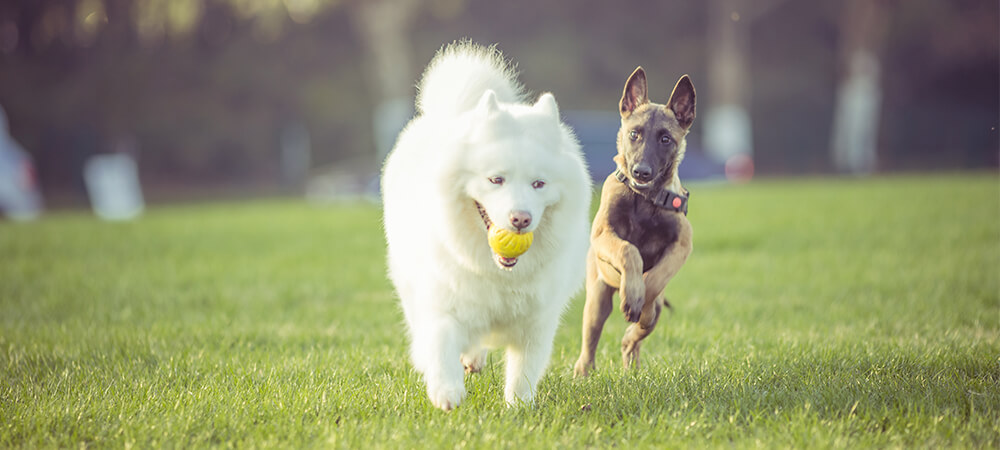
[{"left": 0, "top": 0, "right": 1000, "bottom": 217}]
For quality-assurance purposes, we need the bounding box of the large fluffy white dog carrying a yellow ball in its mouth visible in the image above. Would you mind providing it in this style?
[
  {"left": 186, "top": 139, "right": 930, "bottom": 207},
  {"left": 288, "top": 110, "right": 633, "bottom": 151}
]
[{"left": 382, "top": 42, "right": 591, "bottom": 410}]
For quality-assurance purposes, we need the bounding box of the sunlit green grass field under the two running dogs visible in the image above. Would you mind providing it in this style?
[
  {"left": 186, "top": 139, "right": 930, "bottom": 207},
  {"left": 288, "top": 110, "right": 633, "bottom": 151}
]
[{"left": 0, "top": 174, "right": 1000, "bottom": 448}]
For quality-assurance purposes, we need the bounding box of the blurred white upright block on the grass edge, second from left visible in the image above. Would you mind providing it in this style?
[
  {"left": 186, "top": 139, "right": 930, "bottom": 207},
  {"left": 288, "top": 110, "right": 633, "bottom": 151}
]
[{"left": 83, "top": 153, "right": 144, "bottom": 220}]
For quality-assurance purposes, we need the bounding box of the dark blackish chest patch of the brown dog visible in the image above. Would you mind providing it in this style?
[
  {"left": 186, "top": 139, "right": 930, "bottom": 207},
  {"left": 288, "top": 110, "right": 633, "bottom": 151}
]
[{"left": 610, "top": 195, "right": 680, "bottom": 271}]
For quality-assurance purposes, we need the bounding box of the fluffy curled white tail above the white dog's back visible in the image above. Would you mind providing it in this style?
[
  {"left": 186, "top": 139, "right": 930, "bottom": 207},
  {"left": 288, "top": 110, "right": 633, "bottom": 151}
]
[{"left": 417, "top": 41, "right": 524, "bottom": 115}]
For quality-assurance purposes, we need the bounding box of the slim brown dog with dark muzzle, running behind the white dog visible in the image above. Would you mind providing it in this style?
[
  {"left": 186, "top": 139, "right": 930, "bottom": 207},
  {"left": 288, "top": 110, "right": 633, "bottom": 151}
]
[{"left": 574, "top": 67, "right": 695, "bottom": 376}]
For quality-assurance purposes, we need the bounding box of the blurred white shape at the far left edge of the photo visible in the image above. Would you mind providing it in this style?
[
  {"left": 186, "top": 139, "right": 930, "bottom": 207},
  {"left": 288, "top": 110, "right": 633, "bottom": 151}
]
[{"left": 0, "top": 103, "right": 42, "bottom": 221}]
